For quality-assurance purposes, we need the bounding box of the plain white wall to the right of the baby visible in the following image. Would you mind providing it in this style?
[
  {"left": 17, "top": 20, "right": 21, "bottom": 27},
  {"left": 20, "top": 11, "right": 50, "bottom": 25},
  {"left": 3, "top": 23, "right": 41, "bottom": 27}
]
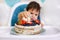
[{"left": 42, "top": 0, "right": 60, "bottom": 26}]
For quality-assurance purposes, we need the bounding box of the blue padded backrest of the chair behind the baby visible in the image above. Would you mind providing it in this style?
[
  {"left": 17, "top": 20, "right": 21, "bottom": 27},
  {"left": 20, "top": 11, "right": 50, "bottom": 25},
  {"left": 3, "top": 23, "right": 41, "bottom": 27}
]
[{"left": 11, "top": 4, "right": 40, "bottom": 26}]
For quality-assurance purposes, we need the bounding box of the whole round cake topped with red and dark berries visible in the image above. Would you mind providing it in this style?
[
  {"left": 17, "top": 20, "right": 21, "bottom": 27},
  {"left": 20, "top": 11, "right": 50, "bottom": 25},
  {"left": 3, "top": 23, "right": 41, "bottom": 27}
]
[{"left": 14, "top": 14, "right": 41, "bottom": 34}]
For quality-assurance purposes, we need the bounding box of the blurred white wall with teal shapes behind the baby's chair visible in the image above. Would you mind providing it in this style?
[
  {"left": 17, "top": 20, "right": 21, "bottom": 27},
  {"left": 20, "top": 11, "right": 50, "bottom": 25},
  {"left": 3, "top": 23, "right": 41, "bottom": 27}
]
[{"left": 0, "top": 0, "right": 60, "bottom": 26}]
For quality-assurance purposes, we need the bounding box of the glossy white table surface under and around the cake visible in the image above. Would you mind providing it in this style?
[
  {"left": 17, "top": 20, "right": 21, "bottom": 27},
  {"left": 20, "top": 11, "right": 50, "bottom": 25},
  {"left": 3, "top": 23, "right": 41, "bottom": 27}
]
[{"left": 0, "top": 26, "right": 60, "bottom": 40}]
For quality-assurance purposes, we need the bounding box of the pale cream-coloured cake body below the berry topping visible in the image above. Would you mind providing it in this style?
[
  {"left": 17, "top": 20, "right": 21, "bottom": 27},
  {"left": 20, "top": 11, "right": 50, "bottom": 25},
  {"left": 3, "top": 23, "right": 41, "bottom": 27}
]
[{"left": 14, "top": 24, "right": 41, "bottom": 34}]
